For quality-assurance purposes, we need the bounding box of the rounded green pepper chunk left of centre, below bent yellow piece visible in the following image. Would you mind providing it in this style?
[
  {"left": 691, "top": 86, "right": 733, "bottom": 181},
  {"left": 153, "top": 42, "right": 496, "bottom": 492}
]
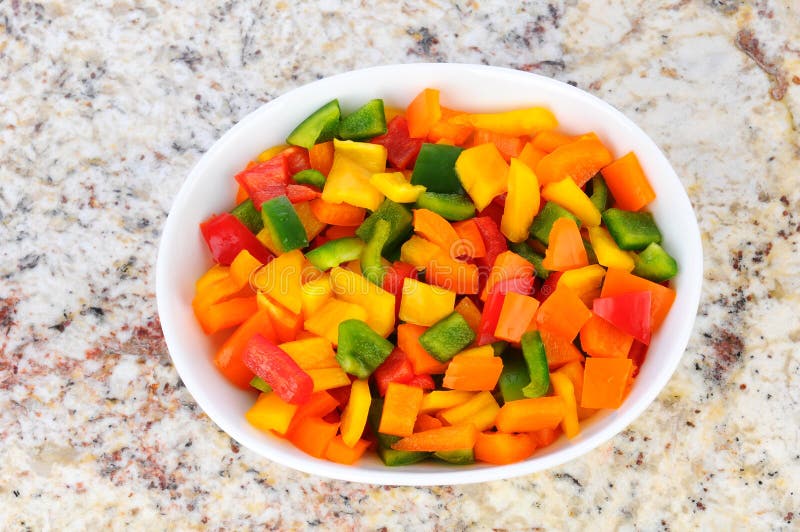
[{"left": 336, "top": 320, "right": 394, "bottom": 379}]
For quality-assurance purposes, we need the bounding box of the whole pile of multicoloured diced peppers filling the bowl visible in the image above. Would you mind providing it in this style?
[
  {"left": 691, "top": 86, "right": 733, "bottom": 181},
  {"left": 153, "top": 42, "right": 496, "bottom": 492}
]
[{"left": 193, "top": 89, "right": 677, "bottom": 466}]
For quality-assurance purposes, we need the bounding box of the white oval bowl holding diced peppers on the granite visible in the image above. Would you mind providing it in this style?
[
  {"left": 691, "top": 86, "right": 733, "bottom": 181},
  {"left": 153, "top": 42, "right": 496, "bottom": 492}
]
[{"left": 156, "top": 64, "right": 702, "bottom": 486}]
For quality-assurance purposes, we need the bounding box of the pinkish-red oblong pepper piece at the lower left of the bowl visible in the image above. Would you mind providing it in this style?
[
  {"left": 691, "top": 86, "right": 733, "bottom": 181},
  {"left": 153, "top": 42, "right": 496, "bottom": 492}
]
[{"left": 242, "top": 334, "right": 314, "bottom": 405}]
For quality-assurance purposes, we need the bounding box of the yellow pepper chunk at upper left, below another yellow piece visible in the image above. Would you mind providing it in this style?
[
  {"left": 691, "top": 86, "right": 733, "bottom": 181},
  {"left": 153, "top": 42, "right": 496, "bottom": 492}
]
[{"left": 322, "top": 152, "right": 383, "bottom": 211}]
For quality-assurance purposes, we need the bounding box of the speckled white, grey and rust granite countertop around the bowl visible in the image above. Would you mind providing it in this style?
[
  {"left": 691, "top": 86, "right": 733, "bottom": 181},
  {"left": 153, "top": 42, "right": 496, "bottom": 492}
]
[{"left": 0, "top": 0, "right": 800, "bottom": 530}]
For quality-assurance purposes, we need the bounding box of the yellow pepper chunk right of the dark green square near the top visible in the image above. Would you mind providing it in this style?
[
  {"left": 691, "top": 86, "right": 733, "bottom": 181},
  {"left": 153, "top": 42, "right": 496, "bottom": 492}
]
[{"left": 456, "top": 142, "right": 508, "bottom": 211}]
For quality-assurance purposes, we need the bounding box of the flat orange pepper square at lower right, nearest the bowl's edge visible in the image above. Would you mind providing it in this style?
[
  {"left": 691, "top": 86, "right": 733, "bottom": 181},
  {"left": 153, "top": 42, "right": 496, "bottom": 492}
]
[{"left": 581, "top": 358, "right": 633, "bottom": 408}]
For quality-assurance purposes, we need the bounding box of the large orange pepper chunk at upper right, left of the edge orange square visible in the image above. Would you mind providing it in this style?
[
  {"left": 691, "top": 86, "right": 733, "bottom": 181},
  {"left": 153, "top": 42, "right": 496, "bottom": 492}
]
[{"left": 536, "top": 138, "right": 612, "bottom": 187}]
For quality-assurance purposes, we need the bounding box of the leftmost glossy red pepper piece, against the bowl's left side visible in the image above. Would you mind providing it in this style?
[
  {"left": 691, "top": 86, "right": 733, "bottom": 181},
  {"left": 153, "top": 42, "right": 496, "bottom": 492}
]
[{"left": 200, "top": 212, "right": 272, "bottom": 266}]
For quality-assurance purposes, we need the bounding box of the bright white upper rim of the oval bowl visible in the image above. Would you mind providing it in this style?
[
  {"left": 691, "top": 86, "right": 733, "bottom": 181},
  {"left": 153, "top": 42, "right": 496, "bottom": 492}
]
[{"left": 156, "top": 63, "right": 703, "bottom": 486}]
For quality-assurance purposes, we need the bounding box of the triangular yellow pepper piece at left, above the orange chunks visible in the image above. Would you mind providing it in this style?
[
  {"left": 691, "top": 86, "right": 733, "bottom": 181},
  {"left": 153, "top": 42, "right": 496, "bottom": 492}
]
[{"left": 253, "top": 249, "right": 306, "bottom": 314}]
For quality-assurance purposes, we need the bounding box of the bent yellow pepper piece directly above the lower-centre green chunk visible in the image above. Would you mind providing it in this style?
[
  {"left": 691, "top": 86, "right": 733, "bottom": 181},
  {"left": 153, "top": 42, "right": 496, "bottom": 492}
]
[{"left": 330, "top": 266, "right": 395, "bottom": 337}]
